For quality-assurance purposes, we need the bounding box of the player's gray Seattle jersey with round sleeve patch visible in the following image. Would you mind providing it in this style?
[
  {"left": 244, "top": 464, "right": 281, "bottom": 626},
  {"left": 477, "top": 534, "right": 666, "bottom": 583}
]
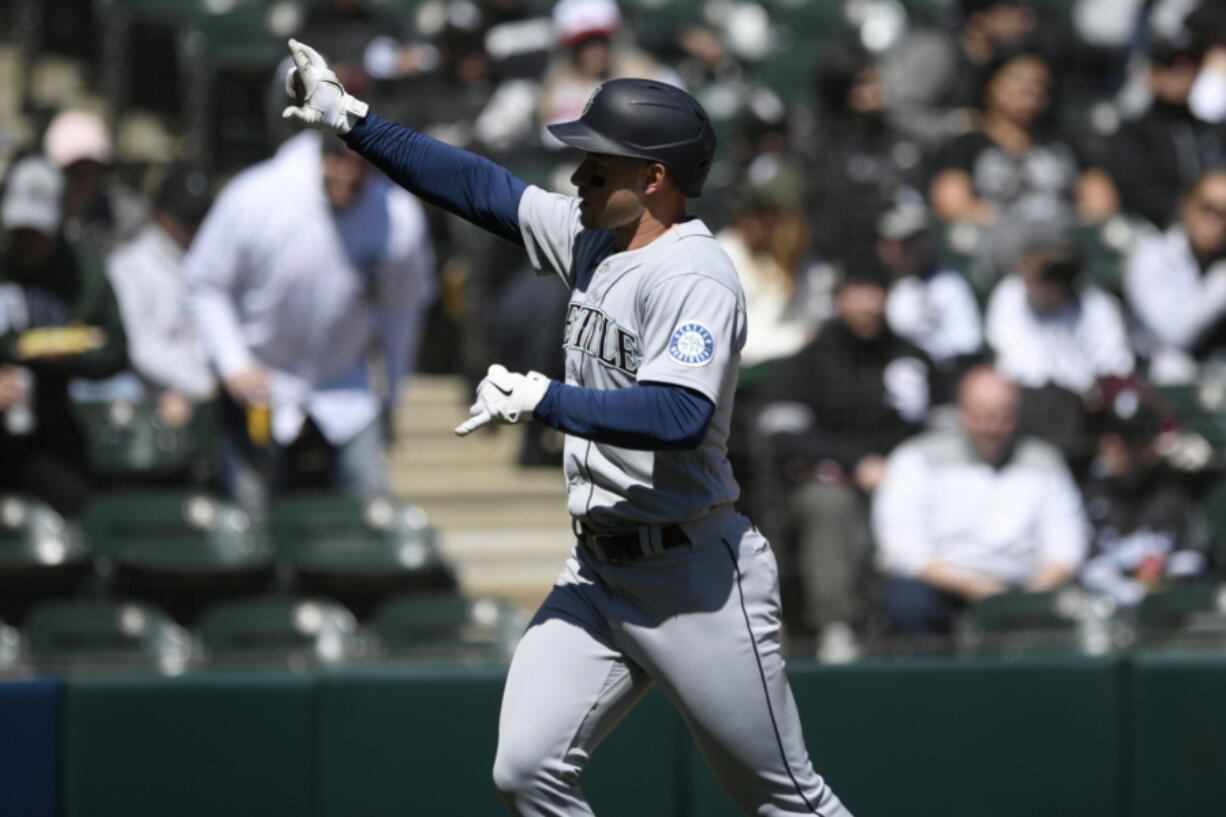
[{"left": 520, "top": 186, "right": 745, "bottom": 526}]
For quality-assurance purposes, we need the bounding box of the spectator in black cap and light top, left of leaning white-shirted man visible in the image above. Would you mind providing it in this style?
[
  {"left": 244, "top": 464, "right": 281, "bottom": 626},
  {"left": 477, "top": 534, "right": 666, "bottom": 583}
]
[{"left": 107, "top": 166, "right": 216, "bottom": 428}]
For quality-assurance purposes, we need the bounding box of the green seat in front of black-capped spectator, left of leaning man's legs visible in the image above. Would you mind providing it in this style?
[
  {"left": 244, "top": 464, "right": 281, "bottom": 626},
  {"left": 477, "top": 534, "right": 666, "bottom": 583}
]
[{"left": 74, "top": 400, "right": 217, "bottom": 482}]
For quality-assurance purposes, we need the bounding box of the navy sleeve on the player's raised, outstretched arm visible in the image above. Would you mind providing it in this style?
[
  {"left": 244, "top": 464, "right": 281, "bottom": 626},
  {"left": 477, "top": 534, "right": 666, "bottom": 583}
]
[{"left": 342, "top": 112, "right": 528, "bottom": 244}]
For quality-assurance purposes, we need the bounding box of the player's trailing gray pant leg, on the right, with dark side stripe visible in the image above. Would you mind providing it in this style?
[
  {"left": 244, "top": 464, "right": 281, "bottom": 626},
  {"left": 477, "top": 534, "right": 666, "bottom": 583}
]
[{"left": 602, "top": 516, "right": 850, "bottom": 817}]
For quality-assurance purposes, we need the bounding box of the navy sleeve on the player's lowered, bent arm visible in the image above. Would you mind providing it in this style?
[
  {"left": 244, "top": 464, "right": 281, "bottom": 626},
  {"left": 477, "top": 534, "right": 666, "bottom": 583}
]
[{"left": 532, "top": 380, "right": 715, "bottom": 451}]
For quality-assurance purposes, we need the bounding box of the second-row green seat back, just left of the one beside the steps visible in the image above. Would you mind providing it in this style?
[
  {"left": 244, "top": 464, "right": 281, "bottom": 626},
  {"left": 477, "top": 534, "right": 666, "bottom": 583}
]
[{"left": 85, "top": 491, "right": 272, "bottom": 572}]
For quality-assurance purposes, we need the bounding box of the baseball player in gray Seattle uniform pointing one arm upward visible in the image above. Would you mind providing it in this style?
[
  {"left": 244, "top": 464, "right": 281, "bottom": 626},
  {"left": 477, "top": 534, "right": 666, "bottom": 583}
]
[{"left": 284, "top": 34, "right": 848, "bottom": 817}]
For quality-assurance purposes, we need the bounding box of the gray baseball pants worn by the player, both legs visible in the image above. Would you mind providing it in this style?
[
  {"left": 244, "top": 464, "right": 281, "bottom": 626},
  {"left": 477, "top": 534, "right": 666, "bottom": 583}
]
[{"left": 494, "top": 507, "right": 851, "bottom": 817}]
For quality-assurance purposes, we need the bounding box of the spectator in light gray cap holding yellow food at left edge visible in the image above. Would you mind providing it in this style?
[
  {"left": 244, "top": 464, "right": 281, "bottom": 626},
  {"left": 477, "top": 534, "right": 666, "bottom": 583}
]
[{"left": 0, "top": 157, "right": 128, "bottom": 516}]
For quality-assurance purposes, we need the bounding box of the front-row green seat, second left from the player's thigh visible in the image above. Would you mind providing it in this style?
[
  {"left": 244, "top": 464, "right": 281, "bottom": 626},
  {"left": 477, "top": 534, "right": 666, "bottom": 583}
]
[{"left": 200, "top": 596, "right": 365, "bottom": 666}]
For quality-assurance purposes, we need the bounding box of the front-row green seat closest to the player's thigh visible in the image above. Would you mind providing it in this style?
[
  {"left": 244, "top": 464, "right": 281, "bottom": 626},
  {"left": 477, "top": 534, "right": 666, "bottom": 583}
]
[{"left": 373, "top": 594, "right": 526, "bottom": 661}]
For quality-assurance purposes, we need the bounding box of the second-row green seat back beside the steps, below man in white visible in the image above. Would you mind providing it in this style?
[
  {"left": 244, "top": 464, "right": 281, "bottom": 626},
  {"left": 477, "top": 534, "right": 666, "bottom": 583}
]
[{"left": 268, "top": 493, "right": 441, "bottom": 575}]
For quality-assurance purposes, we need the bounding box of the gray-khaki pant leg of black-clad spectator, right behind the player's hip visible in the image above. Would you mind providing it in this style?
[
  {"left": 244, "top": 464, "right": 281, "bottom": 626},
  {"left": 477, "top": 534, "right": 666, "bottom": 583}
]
[{"left": 788, "top": 480, "right": 864, "bottom": 629}]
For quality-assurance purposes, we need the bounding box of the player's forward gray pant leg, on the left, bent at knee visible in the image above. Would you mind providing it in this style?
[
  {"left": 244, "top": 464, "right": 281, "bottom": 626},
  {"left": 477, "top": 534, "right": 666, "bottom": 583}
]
[{"left": 494, "top": 547, "right": 651, "bottom": 817}]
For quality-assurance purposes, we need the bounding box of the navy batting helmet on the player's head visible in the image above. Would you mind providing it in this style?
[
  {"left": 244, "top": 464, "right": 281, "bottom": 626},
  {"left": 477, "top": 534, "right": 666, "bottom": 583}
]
[{"left": 549, "top": 80, "right": 715, "bottom": 199}]
